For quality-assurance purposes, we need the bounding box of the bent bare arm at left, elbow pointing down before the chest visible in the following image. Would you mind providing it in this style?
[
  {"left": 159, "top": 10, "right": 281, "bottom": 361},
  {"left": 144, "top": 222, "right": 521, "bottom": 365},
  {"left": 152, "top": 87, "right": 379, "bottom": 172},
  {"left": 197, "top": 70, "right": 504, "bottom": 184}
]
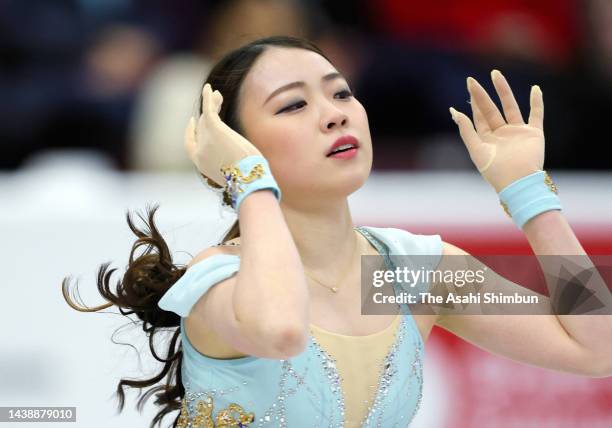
[{"left": 189, "top": 191, "right": 309, "bottom": 359}]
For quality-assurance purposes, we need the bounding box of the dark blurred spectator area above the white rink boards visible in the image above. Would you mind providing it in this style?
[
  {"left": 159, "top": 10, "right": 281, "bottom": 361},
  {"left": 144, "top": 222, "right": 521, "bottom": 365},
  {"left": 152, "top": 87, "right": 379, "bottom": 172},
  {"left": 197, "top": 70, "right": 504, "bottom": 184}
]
[{"left": 0, "top": 0, "right": 612, "bottom": 170}]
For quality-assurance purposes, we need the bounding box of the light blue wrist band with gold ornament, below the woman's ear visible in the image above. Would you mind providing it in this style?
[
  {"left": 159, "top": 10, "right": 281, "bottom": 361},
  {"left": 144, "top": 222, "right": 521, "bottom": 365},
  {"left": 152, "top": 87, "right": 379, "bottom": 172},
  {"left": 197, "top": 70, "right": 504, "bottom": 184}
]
[{"left": 221, "top": 155, "right": 281, "bottom": 213}]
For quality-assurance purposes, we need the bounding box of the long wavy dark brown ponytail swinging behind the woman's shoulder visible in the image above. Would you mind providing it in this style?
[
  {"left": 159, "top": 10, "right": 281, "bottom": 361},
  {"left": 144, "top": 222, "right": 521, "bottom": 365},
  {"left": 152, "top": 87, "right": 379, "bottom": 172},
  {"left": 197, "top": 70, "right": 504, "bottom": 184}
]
[{"left": 62, "top": 205, "right": 186, "bottom": 428}]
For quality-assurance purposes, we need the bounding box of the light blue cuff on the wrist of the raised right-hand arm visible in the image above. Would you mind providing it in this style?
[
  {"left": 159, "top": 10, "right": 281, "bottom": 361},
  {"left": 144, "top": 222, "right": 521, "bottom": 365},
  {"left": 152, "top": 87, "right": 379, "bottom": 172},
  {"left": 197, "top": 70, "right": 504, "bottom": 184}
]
[{"left": 499, "top": 171, "right": 562, "bottom": 229}]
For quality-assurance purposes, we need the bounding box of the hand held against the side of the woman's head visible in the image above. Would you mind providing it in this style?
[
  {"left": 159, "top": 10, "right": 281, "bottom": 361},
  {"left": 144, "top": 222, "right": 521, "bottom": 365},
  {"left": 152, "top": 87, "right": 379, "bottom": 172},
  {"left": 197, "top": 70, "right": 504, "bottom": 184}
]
[{"left": 185, "top": 83, "right": 261, "bottom": 186}]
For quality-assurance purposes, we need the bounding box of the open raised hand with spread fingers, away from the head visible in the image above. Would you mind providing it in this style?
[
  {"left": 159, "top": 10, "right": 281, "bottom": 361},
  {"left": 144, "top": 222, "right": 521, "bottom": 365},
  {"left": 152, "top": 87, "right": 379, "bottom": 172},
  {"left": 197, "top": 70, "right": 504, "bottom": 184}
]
[{"left": 450, "top": 70, "right": 544, "bottom": 193}]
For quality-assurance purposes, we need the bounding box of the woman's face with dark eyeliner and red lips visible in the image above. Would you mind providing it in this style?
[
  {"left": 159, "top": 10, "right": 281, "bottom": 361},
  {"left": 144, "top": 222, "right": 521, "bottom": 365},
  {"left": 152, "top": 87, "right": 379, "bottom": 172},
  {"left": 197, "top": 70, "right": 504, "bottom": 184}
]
[{"left": 238, "top": 47, "right": 372, "bottom": 202}]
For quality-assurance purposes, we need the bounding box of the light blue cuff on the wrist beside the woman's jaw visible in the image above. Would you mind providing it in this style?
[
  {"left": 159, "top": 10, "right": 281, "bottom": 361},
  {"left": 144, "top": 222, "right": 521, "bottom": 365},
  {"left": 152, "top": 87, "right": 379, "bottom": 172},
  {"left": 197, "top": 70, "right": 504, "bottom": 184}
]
[{"left": 225, "top": 155, "right": 281, "bottom": 213}]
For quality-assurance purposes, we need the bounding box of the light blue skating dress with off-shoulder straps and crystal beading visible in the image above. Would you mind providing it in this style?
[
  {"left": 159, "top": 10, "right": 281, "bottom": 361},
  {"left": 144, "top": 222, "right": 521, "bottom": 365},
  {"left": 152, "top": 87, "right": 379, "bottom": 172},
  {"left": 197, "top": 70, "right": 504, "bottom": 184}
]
[{"left": 159, "top": 226, "right": 442, "bottom": 428}]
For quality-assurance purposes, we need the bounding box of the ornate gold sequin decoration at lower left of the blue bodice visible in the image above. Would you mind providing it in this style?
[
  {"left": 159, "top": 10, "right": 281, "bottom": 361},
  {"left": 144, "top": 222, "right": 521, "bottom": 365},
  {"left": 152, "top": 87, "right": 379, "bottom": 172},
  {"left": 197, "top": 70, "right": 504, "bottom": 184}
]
[{"left": 176, "top": 396, "right": 255, "bottom": 428}]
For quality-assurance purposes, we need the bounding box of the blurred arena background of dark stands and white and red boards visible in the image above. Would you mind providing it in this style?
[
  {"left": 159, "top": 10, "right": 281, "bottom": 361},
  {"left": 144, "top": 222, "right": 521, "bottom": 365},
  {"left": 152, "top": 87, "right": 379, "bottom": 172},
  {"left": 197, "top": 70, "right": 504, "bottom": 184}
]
[{"left": 0, "top": 0, "right": 612, "bottom": 428}]
